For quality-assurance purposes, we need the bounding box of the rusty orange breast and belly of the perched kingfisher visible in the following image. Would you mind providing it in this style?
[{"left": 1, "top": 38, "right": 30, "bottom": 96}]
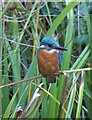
[{"left": 38, "top": 49, "right": 59, "bottom": 76}]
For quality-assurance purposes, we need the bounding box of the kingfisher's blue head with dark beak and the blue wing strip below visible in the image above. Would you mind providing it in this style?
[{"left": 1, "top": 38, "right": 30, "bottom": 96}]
[{"left": 40, "top": 37, "right": 67, "bottom": 68}]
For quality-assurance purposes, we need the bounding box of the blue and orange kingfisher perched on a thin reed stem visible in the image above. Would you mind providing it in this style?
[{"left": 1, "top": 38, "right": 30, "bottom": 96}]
[{"left": 38, "top": 37, "right": 67, "bottom": 83}]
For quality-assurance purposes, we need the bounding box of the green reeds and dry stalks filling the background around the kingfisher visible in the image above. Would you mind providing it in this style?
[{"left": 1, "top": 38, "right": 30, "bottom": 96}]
[{"left": 0, "top": 0, "right": 92, "bottom": 119}]
